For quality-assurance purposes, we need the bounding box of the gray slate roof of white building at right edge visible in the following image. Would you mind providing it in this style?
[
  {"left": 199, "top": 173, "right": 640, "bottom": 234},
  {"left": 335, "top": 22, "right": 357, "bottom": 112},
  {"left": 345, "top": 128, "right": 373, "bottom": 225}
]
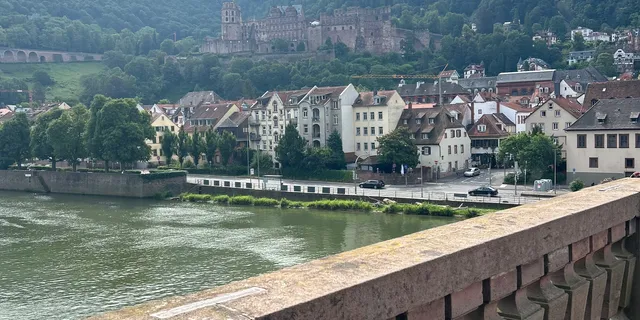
[{"left": 565, "top": 98, "right": 640, "bottom": 131}]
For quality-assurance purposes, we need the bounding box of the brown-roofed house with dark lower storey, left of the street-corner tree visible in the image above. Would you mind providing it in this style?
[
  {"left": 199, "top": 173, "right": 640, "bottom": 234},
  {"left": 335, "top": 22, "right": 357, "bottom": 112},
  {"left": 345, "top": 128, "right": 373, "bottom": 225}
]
[{"left": 469, "top": 113, "right": 516, "bottom": 166}]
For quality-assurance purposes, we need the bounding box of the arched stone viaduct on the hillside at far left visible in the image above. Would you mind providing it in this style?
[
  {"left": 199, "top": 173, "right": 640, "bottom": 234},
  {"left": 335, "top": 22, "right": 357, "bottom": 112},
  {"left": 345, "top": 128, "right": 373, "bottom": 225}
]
[{"left": 0, "top": 48, "right": 102, "bottom": 63}]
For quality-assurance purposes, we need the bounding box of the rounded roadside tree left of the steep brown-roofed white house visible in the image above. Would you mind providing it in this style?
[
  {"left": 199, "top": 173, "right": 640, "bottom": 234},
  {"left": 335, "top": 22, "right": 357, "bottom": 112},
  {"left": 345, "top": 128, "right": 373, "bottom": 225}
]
[{"left": 378, "top": 127, "right": 419, "bottom": 168}]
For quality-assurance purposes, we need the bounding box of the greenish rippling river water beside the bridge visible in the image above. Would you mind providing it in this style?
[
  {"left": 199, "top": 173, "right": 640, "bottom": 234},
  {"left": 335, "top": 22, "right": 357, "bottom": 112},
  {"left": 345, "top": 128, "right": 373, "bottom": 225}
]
[{"left": 0, "top": 192, "right": 456, "bottom": 319}]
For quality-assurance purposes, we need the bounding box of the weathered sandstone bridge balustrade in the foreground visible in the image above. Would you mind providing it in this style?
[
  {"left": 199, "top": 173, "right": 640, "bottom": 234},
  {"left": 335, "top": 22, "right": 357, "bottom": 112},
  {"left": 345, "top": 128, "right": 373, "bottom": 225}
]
[{"left": 89, "top": 179, "right": 640, "bottom": 320}]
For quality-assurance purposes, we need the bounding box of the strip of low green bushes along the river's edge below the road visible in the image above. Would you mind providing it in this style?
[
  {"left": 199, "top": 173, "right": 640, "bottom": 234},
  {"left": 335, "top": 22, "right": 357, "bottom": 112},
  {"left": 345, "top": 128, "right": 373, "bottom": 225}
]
[{"left": 180, "top": 193, "right": 495, "bottom": 218}]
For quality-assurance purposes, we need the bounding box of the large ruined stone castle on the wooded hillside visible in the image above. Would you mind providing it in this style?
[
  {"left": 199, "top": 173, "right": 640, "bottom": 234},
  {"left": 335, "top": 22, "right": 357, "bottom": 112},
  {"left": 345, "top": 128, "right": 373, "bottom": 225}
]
[{"left": 200, "top": 2, "right": 441, "bottom": 54}]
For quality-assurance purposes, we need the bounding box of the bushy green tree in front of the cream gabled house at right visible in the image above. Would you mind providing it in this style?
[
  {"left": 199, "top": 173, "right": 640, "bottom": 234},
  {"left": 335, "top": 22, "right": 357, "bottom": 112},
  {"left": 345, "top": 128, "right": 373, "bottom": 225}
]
[{"left": 498, "top": 131, "right": 561, "bottom": 180}]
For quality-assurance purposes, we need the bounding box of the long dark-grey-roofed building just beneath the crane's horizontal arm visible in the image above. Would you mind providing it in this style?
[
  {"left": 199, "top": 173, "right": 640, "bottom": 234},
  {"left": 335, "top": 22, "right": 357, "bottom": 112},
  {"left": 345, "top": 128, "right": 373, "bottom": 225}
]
[{"left": 397, "top": 80, "right": 468, "bottom": 104}]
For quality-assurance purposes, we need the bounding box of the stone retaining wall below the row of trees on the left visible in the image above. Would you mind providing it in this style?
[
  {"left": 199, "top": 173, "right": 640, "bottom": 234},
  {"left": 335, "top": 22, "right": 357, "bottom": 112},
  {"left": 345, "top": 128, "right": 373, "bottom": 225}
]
[{"left": 0, "top": 170, "right": 186, "bottom": 198}]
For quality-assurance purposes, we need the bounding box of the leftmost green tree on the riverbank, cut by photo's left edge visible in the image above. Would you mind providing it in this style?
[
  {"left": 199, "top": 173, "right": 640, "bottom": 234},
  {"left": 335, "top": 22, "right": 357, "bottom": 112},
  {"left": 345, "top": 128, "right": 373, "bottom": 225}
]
[{"left": 0, "top": 112, "right": 31, "bottom": 168}]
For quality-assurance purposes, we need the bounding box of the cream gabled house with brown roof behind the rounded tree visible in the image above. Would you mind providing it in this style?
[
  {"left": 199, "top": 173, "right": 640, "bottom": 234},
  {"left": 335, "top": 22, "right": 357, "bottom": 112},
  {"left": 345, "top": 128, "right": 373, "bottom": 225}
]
[{"left": 525, "top": 98, "right": 583, "bottom": 158}]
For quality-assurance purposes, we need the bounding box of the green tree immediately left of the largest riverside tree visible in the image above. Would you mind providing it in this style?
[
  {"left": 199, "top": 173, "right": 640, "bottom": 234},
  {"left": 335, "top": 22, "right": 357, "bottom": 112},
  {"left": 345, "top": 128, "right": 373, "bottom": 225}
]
[{"left": 47, "top": 105, "right": 90, "bottom": 172}]
